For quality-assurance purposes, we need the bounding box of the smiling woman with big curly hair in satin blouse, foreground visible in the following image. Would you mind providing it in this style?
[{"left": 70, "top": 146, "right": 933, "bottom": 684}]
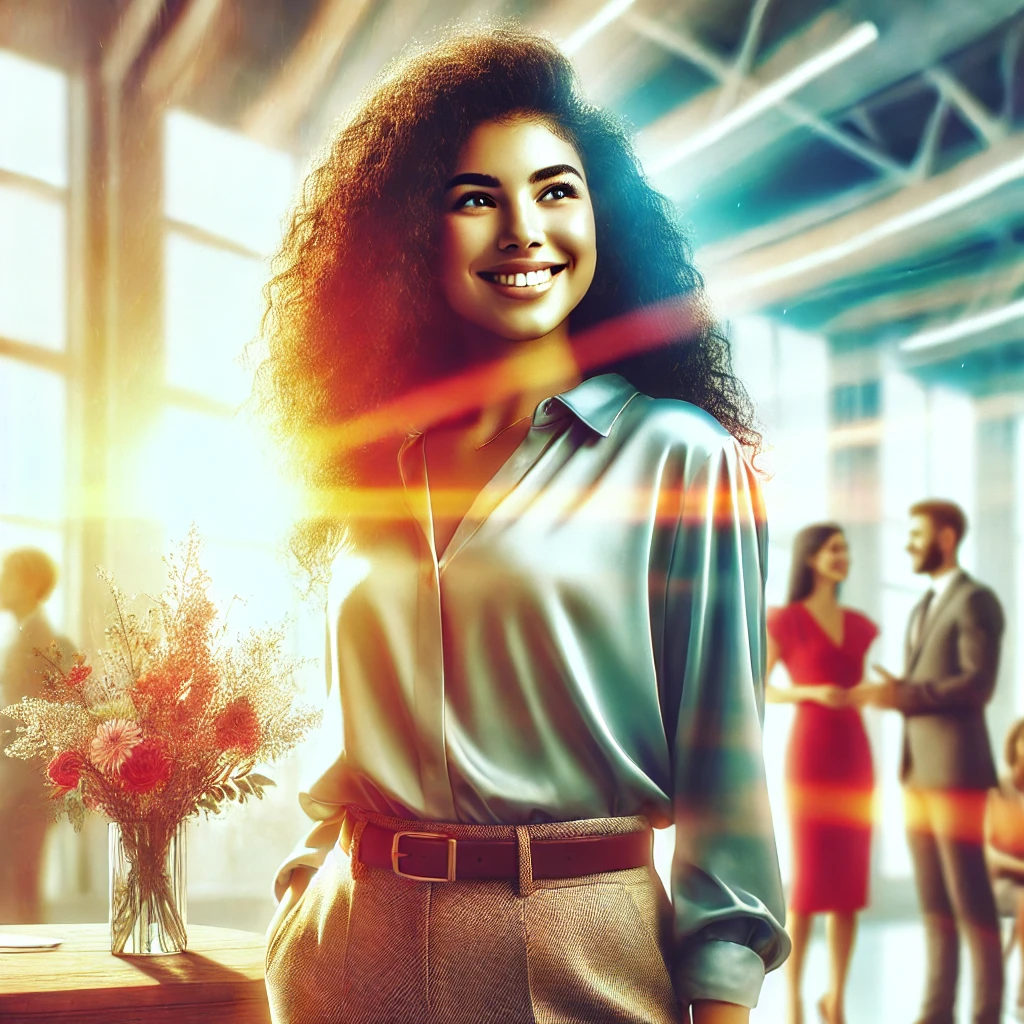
[{"left": 260, "top": 24, "right": 787, "bottom": 1024}]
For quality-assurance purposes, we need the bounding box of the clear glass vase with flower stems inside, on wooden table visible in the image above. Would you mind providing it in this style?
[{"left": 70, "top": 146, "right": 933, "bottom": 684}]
[{"left": 108, "top": 821, "right": 187, "bottom": 955}]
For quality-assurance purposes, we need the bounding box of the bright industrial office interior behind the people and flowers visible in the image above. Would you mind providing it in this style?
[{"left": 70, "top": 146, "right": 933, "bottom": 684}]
[{"left": 0, "top": 0, "right": 1024, "bottom": 1021}]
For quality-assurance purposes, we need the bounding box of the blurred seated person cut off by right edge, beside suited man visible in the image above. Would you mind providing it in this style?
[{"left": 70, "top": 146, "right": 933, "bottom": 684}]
[{"left": 985, "top": 719, "right": 1024, "bottom": 1021}]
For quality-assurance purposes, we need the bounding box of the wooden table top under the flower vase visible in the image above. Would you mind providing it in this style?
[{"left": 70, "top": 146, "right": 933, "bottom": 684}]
[{"left": 0, "top": 924, "right": 270, "bottom": 1024}]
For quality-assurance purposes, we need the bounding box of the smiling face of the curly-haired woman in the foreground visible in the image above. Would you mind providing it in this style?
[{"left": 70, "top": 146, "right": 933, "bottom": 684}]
[{"left": 439, "top": 119, "right": 597, "bottom": 341}]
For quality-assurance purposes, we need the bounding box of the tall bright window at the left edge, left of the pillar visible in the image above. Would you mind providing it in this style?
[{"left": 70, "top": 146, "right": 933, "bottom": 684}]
[{"left": 0, "top": 50, "right": 69, "bottom": 629}]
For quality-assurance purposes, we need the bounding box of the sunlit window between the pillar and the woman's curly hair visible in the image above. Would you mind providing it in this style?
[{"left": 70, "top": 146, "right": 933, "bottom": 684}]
[{"left": 157, "top": 111, "right": 296, "bottom": 622}]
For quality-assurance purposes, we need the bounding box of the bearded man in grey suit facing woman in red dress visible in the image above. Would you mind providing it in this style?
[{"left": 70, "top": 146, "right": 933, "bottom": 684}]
[{"left": 859, "top": 501, "right": 1004, "bottom": 1024}]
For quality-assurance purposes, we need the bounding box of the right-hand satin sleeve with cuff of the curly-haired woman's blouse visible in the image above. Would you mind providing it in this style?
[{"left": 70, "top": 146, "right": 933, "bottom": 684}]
[{"left": 659, "top": 437, "right": 790, "bottom": 1007}]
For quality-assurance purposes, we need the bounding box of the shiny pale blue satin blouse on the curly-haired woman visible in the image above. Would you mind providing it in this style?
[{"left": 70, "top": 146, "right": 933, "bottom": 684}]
[{"left": 278, "top": 374, "right": 788, "bottom": 1006}]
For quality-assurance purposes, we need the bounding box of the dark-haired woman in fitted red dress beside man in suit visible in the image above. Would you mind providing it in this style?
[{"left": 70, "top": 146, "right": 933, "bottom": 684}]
[{"left": 766, "top": 523, "right": 879, "bottom": 1024}]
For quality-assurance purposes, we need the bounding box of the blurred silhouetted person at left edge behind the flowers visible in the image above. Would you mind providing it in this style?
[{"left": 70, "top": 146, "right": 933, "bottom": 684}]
[{"left": 0, "top": 548, "right": 73, "bottom": 925}]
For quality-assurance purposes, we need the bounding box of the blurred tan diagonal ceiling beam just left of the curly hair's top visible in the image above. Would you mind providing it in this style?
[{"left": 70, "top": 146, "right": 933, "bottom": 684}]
[{"left": 243, "top": 0, "right": 374, "bottom": 145}]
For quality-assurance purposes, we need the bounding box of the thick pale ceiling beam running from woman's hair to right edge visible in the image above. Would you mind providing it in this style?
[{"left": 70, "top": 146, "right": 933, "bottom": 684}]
[{"left": 700, "top": 133, "right": 1024, "bottom": 314}]
